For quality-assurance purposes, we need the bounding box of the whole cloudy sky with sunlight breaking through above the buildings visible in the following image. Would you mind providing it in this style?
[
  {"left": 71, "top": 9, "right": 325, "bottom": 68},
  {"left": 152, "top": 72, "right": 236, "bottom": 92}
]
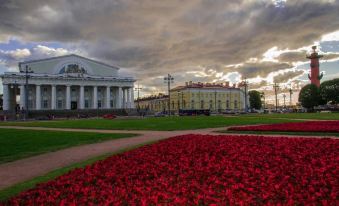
[{"left": 0, "top": 0, "right": 339, "bottom": 103}]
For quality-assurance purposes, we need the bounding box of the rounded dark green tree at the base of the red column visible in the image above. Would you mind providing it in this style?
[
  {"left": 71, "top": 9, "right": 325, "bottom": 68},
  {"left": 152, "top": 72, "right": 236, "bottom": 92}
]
[{"left": 299, "top": 84, "right": 321, "bottom": 110}]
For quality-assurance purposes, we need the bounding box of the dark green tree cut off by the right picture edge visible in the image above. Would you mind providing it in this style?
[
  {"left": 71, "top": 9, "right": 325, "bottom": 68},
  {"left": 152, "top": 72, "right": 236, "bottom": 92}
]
[{"left": 320, "top": 78, "right": 339, "bottom": 104}]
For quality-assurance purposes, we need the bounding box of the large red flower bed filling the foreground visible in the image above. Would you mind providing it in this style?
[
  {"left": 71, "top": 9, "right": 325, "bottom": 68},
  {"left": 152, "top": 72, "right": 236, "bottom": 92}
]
[{"left": 5, "top": 135, "right": 339, "bottom": 205}]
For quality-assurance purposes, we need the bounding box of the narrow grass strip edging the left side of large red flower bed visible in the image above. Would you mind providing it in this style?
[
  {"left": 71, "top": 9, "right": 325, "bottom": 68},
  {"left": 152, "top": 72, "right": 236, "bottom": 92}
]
[{"left": 0, "top": 141, "right": 157, "bottom": 202}]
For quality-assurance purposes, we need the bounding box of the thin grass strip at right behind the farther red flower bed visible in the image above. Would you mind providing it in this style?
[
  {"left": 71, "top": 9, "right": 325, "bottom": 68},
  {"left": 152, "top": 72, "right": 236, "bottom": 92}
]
[{"left": 247, "top": 113, "right": 339, "bottom": 120}]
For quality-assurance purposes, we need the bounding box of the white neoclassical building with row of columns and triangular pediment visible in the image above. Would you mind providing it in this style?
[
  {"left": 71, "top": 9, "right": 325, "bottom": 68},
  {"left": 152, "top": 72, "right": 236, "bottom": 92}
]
[{"left": 1, "top": 54, "right": 135, "bottom": 111}]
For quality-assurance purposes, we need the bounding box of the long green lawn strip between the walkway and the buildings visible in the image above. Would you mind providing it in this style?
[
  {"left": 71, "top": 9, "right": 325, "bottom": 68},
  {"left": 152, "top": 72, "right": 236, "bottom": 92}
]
[{"left": 0, "top": 116, "right": 302, "bottom": 131}]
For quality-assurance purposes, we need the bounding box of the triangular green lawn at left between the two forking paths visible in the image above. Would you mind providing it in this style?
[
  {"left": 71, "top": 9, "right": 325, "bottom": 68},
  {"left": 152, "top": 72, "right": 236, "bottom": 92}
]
[{"left": 0, "top": 129, "right": 134, "bottom": 164}]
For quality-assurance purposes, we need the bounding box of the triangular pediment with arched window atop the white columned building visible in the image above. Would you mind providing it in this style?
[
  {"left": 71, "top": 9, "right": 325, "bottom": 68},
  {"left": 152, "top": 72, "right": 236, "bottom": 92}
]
[{"left": 19, "top": 54, "right": 119, "bottom": 77}]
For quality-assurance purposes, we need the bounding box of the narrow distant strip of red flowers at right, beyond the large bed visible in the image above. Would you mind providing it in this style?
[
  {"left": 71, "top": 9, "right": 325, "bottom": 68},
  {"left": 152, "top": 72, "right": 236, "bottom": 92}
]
[{"left": 228, "top": 121, "right": 339, "bottom": 132}]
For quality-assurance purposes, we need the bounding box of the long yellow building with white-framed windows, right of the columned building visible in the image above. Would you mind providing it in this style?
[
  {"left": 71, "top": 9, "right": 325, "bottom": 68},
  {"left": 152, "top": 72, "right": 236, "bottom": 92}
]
[{"left": 135, "top": 82, "right": 245, "bottom": 112}]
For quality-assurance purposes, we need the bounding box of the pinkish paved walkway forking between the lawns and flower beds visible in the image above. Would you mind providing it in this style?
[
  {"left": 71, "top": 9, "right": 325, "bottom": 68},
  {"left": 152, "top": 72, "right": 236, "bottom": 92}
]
[{"left": 0, "top": 126, "right": 335, "bottom": 190}]
